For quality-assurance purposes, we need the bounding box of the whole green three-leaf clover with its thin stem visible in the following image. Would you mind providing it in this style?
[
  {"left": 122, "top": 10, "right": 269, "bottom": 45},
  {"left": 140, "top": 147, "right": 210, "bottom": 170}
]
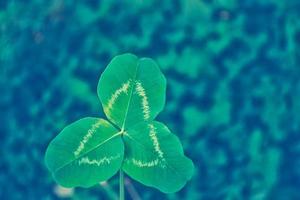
[{"left": 45, "top": 53, "right": 194, "bottom": 199}]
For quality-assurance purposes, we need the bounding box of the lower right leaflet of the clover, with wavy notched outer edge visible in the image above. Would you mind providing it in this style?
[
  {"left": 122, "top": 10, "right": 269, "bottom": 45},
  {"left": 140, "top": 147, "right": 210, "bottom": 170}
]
[{"left": 123, "top": 122, "right": 194, "bottom": 193}]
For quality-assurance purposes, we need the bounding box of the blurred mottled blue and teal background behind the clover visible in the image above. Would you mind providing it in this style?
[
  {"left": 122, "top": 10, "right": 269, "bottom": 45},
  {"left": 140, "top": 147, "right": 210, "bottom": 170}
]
[{"left": 0, "top": 0, "right": 300, "bottom": 200}]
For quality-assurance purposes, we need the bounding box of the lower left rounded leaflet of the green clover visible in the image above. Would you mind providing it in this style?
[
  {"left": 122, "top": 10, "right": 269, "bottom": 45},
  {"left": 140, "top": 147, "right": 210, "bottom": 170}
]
[{"left": 45, "top": 117, "right": 124, "bottom": 187}]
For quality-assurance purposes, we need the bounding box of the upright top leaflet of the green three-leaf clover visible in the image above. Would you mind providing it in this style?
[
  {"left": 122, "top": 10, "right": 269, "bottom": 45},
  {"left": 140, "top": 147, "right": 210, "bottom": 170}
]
[{"left": 97, "top": 54, "right": 166, "bottom": 130}]
